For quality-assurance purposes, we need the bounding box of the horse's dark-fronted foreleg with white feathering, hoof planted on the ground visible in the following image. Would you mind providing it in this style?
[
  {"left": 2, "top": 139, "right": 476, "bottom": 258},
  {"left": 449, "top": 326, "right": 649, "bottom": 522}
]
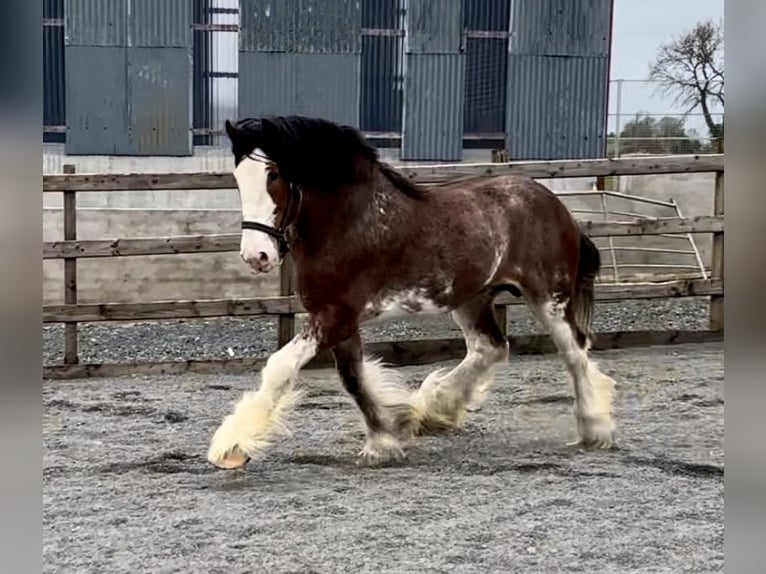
[{"left": 333, "top": 332, "right": 412, "bottom": 464}]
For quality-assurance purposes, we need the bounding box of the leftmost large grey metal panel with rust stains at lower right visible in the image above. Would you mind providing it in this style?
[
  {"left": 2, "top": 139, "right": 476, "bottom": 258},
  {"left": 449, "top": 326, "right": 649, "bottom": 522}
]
[{"left": 65, "top": 0, "right": 192, "bottom": 156}]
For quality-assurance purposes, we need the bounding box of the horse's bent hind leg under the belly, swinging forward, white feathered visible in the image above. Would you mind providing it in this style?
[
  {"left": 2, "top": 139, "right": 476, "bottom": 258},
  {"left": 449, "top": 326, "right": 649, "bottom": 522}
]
[{"left": 413, "top": 293, "right": 508, "bottom": 433}]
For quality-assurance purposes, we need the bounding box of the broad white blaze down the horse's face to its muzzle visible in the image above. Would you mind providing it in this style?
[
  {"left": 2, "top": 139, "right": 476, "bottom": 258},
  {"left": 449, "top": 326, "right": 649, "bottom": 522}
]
[{"left": 234, "top": 149, "right": 279, "bottom": 271}]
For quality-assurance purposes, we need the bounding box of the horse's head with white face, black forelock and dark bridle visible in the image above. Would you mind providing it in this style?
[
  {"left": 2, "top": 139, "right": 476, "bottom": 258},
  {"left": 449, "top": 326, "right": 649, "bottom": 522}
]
[{"left": 226, "top": 119, "right": 296, "bottom": 273}]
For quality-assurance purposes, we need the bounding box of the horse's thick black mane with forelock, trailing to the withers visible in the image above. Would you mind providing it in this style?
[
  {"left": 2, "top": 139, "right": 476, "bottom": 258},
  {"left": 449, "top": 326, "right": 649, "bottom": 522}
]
[{"left": 229, "top": 115, "right": 432, "bottom": 198}]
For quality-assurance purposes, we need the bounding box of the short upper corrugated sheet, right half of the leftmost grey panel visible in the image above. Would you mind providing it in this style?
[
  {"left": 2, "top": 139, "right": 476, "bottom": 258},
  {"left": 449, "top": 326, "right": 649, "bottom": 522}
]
[{"left": 128, "top": 0, "right": 193, "bottom": 48}]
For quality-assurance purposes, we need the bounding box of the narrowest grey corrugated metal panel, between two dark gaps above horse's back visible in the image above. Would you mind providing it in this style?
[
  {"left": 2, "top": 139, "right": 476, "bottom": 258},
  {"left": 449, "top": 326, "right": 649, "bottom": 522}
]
[{"left": 401, "top": 0, "right": 465, "bottom": 161}]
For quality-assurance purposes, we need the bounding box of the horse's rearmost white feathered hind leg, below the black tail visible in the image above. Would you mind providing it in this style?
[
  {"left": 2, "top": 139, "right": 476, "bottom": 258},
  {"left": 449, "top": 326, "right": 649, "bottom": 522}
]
[{"left": 530, "top": 297, "right": 615, "bottom": 448}]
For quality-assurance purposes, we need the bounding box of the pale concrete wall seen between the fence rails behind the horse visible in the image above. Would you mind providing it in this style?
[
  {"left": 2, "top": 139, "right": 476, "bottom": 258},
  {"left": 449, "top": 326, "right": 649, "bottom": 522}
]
[{"left": 43, "top": 149, "right": 714, "bottom": 304}]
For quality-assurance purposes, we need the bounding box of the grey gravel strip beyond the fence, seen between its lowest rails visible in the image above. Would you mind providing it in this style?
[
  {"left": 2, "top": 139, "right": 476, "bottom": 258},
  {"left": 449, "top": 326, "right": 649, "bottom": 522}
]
[{"left": 43, "top": 297, "right": 709, "bottom": 365}]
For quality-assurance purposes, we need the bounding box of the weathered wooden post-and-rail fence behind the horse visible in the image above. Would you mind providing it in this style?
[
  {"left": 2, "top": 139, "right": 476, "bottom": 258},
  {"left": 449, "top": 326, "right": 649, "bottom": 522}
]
[{"left": 43, "top": 154, "right": 724, "bottom": 378}]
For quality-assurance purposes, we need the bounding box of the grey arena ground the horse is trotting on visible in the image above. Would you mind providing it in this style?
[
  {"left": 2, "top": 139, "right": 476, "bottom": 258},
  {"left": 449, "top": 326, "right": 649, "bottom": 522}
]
[{"left": 43, "top": 344, "right": 724, "bottom": 574}]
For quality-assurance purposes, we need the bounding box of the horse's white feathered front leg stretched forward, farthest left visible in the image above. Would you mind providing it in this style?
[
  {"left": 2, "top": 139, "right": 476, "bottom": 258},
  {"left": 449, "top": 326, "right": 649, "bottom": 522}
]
[{"left": 208, "top": 325, "right": 319, "bottom": 469}]
